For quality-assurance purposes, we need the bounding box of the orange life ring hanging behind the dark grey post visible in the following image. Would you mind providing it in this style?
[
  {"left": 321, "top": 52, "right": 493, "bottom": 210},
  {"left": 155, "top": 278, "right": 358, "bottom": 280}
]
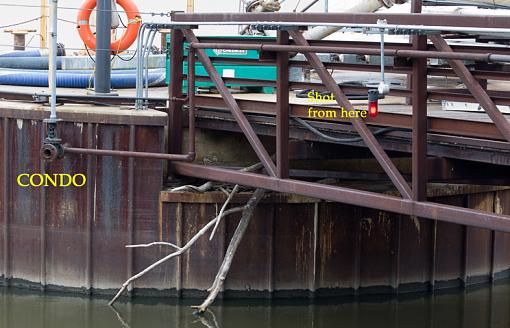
[{"left": 78, "top": 0, "right": 142, "bottom": 54}]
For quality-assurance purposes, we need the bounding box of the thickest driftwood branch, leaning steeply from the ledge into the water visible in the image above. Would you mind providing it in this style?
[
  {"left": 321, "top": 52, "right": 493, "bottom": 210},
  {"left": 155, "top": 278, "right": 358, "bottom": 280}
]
[{"left": 190, "top": 189, "right": 266, "bottom": 314}]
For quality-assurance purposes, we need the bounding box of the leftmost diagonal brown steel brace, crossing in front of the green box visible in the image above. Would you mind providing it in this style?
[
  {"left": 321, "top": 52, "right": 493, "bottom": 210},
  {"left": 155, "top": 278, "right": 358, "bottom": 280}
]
[{"left": 183, "top": 29, "right": 276, "bottom": 177}]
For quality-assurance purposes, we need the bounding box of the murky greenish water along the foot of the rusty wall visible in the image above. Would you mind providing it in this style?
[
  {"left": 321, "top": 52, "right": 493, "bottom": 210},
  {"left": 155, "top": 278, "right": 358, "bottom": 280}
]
[{"left": 0, "top": 283, "right": 510, "bottom": 328}]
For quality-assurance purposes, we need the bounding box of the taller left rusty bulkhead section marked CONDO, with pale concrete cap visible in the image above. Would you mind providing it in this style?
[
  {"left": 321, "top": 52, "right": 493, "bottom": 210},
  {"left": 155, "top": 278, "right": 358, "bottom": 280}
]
[{"left": 0, "top": 103, "right": 167, "bottom": 291}]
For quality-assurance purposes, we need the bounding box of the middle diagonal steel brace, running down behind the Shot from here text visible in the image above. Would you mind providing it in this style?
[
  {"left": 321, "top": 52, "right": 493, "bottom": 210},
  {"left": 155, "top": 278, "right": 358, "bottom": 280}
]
[{"left": 289, "top": 30, "right": 412, "bottom": 199}]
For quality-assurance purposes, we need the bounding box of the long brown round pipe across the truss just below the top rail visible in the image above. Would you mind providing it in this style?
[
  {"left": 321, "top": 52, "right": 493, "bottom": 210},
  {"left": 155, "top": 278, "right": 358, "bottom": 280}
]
[{"left": 188, "top": 42, "right": 510, "bottom": 62}]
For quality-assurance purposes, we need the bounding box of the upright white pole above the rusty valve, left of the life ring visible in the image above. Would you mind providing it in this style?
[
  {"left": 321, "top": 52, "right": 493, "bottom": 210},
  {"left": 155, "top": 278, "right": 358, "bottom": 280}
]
[{"left": 48, "top": 0, "right": 58, "bottom": 122}]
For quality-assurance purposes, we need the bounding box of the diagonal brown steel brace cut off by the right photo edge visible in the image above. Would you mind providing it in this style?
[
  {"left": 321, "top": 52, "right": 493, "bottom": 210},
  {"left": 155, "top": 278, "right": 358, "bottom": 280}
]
[{"left": 429, "top": 35, "right": 510, "bottom": 142}]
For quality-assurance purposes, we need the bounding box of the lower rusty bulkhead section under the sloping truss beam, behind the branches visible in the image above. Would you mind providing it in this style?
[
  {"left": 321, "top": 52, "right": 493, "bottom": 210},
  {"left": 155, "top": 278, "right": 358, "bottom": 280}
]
[{"left": 157, "top": 185, "right": 510, "bottom": 297}]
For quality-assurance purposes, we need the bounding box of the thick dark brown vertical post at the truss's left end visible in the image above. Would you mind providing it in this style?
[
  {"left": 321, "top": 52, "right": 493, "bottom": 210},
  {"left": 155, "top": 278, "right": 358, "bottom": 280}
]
[{"left": 168, "top": 29, "right": 184, "bottom": 167}]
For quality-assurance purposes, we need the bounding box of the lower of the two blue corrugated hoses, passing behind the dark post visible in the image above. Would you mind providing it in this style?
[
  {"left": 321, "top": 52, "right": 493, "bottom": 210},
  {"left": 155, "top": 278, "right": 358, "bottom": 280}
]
[{"left": 0, "top": 69, "right": 166, "bottom": 89}]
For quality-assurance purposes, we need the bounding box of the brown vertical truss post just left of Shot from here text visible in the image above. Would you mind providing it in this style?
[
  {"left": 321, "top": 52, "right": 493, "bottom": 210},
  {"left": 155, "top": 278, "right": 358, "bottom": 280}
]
[{"left": 276, "top": 31, "right": 289, "bottom": 179}]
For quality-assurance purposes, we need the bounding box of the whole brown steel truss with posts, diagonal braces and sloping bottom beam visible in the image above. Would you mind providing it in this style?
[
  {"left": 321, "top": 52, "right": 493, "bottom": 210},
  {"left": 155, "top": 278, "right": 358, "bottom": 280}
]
[{"left": 46, "top": 7, "right": 510, "bottom": 232}]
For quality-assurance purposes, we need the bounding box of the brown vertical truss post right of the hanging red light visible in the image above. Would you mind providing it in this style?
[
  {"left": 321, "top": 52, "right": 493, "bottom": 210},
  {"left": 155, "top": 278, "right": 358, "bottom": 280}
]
[{"left": 412, "top": 0, "right": 428, "bottom": 201}]
